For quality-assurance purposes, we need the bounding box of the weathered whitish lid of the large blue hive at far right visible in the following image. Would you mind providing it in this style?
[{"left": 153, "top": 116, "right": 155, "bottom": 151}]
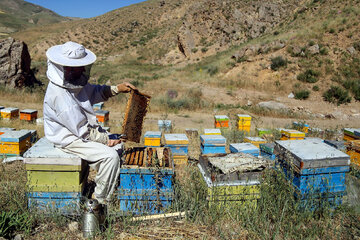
[{"left": 275, "top": 139, "right": 350, "bottom": 169}]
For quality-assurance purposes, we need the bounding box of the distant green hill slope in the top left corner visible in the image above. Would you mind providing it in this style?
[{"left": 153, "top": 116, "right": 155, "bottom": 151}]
[{"left": 0, "top": 0, "right": 69, "bottom": 37}]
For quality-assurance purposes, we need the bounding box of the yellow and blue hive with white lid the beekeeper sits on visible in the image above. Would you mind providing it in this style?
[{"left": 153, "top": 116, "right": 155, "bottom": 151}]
[{"left": 24, "top": 138, "right": 88, "bottom": 215}]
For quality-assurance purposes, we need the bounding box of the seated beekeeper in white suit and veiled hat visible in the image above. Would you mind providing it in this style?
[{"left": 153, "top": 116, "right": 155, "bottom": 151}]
[{"left": 44, "top": 42, "right": 136, "bottom": 204}]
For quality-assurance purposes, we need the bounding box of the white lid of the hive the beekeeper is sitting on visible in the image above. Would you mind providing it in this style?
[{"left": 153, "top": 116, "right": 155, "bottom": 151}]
[{"left": 24, "top": 137, "right": 81, "bottom": 165}]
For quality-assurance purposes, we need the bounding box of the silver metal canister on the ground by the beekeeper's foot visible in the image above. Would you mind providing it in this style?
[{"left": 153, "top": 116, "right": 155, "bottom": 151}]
[{"left": 82, "top": 199, "right": 106, "bottom": 238}]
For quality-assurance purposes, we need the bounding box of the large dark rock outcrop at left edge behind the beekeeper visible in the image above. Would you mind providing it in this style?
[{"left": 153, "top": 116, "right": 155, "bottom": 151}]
[{"left": 0, "top": 38, "right": 37, "bottom": 88}]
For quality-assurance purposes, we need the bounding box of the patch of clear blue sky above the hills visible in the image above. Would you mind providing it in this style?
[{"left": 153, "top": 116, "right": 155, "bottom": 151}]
[{"left": 26, "top": 0, "right": 145, "bottom": 18}]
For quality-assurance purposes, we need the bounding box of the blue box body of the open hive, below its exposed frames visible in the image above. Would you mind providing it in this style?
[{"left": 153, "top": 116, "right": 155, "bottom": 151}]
[{"left": 117, "top": 164, "right": 174, "bottom": 215}]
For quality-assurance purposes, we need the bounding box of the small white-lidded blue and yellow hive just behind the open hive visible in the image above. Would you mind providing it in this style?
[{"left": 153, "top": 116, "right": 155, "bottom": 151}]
[{"left": 164, "top": 134, "right": 189, "bottom": 166}]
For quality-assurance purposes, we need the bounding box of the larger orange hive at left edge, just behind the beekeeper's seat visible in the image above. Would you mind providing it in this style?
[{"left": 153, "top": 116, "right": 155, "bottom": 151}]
[{"left": 0, "top": 131, "right": 31, "bottom": 156}]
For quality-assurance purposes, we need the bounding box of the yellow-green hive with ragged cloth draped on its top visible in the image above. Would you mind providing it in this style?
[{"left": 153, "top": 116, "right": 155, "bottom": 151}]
[{"left": 198, "top": 153, "right": 265, "bottom": 208}]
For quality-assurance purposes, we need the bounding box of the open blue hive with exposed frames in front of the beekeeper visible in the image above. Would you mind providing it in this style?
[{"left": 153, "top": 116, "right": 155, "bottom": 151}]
[{"left": 116, "top": 147, "right": 174, "bottom": 215}]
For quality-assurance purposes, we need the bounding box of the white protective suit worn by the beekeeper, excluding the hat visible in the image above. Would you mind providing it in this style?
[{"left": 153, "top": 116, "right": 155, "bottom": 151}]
[{"left": 44, "top": 61, "right": 120, "bottom": 202}]
